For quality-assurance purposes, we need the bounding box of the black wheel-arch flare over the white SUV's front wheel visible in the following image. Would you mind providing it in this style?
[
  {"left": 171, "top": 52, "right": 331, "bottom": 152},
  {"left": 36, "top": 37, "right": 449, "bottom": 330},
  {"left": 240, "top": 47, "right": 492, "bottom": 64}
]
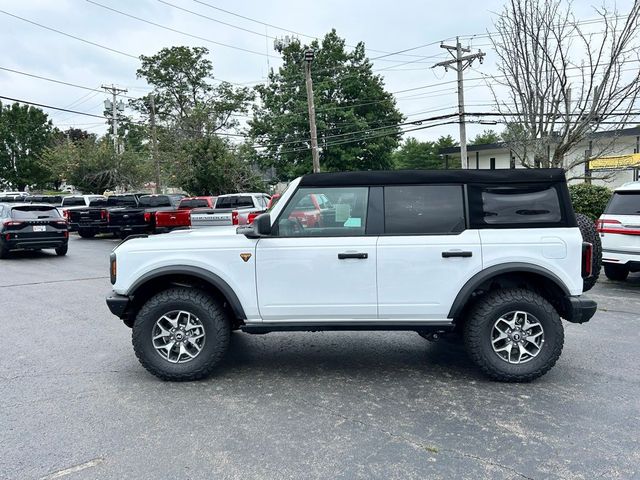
[{"left": 127, "top": 265, "right": 246, "bottom": 322}]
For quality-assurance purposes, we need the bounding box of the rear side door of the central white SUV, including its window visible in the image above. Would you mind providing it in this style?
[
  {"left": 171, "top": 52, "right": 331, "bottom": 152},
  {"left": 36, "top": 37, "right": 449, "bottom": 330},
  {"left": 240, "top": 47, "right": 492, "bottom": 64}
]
[{"left": 378, "top": 185, "right": 482, "bottom": 321}]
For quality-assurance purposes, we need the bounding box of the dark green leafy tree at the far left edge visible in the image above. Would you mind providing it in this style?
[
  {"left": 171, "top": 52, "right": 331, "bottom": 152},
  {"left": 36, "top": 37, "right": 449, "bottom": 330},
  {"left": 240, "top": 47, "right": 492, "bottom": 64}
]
[{"left": 0, "top": 102, "right": 54, "bottom": 190}]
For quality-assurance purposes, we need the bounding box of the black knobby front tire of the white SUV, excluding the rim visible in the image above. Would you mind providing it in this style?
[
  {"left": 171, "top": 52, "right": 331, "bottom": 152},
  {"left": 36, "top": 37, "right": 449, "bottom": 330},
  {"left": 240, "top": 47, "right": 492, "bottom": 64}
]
[{"left": 131, "top": 288, "right": 231, "bottom": 382}]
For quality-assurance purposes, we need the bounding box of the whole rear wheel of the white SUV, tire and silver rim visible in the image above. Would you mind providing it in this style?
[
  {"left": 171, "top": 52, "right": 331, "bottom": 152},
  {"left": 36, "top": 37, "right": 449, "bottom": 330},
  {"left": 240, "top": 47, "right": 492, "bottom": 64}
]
[{"left": 464, "top": 289, "right": 564, "bottom": 382}]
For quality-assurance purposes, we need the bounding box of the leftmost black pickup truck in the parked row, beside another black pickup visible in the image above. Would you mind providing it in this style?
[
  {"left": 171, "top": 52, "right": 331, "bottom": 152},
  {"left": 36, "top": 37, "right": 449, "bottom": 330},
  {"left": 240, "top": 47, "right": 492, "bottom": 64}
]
[{"left": 67, "top": 193, "right": 141, "bottom": 238}]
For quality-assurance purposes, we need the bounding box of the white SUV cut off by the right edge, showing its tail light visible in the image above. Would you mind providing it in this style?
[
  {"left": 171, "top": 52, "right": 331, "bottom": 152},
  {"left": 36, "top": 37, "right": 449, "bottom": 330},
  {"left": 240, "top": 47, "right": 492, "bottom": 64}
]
[{"left": 598, "top": 182, "right": 640, "bottom": 280}]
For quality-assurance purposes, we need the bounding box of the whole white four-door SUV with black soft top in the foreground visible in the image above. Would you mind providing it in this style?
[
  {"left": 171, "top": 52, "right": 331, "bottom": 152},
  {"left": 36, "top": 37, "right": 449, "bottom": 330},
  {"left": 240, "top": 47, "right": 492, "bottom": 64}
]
[{"left": 107, "top": 169, "right": 596, "bottom": 381}]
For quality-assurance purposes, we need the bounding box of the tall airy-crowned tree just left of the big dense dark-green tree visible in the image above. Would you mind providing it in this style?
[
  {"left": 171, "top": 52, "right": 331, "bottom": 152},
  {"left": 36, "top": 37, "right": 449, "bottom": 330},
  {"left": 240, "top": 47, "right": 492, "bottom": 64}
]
[{"left": 131, "top": 47, "right": 254, "bottom": 193}]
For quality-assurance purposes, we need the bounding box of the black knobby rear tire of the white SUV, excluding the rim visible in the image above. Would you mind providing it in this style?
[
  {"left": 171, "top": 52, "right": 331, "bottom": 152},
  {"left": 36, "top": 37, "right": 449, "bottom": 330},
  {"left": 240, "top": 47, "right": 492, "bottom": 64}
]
[{"left": 464, "top": 289, "right": 564, "bottom": 382}]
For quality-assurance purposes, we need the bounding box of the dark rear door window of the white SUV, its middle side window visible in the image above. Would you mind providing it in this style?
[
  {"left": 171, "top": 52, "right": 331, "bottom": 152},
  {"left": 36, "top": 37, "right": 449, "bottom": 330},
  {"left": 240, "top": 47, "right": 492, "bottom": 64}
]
[{"left": 384, "top": 185, "right": 465, "bottom": 235}]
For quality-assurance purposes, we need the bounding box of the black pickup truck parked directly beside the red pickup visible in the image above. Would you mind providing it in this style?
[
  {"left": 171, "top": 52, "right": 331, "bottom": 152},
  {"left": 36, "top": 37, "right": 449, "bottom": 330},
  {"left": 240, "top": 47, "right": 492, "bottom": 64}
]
[{"left": 109, "top": 195, "right": 184, "bottom": 238}]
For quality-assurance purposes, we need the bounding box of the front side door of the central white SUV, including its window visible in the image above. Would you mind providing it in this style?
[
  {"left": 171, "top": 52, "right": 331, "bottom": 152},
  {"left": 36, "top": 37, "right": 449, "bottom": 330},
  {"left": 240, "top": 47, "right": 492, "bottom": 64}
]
[{"left": 256, "top": 187, "right": 377, "bottom": 322}]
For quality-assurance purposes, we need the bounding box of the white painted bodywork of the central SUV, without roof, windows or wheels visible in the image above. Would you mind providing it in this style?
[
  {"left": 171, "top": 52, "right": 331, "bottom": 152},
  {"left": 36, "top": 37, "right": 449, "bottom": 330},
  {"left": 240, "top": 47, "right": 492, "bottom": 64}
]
[{"left": 114, "top": 172, "right": 583, "bottom": 326}]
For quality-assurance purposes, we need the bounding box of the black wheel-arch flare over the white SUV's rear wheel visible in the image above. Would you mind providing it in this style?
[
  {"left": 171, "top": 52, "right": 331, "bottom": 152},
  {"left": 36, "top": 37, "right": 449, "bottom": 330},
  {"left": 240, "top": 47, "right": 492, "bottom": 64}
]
[{"left": 448, "top": 262, "right": 571, "bottom": 323}]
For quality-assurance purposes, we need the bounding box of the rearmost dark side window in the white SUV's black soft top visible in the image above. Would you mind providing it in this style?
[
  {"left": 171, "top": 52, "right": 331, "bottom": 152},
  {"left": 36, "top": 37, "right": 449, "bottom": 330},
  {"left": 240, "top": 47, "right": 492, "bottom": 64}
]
[{"left": 482, "top": 186, "right": 562, "bottom": 225}]
